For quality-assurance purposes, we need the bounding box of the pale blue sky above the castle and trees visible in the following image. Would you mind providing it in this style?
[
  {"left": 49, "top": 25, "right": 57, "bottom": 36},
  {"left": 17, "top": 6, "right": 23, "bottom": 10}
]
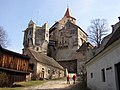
[{"left": 0, "top": 0, "right": 120, "bottom": 53}]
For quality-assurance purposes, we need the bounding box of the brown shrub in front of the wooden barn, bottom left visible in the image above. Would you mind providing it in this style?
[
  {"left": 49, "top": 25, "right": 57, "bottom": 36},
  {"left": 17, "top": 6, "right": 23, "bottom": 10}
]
[{"left": 0, "top": 72, "right": 9, "bottom": 87}]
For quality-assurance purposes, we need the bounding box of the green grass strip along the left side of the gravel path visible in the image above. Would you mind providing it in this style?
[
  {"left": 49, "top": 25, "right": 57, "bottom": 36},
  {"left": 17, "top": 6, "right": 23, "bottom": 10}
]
[{"left": 0, "top": 80, "right": 47, "bottom": 90}]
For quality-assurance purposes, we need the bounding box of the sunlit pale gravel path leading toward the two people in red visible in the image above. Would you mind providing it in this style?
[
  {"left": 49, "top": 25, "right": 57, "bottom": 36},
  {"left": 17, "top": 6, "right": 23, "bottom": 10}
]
[{"left": 25, "top": 78, "right": 78, "bottom": 90}]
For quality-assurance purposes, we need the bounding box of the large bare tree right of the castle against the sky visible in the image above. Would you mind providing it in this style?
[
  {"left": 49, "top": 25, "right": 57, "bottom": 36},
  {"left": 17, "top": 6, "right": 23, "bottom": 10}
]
[{"left": 88, "top": 19, "right": 109, "bottom": 47}]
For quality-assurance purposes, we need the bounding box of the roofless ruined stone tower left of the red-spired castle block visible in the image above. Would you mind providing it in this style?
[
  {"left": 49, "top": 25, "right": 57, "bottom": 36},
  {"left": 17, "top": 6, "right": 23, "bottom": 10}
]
[{"left": 23, "top": 20, "right": 49, "bottom": 54}]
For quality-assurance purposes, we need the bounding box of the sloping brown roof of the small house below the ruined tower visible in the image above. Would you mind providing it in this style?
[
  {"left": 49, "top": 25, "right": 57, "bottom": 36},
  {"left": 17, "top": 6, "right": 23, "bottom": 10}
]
[{"left": 29, "top": 49, "right": 64, "bottom": 69}]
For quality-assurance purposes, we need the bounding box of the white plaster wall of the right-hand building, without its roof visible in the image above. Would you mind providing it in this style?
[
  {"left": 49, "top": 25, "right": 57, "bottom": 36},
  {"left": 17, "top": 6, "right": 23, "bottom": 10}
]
[{"left": 86, "top": 40, "right": 120, "bottom": 90}]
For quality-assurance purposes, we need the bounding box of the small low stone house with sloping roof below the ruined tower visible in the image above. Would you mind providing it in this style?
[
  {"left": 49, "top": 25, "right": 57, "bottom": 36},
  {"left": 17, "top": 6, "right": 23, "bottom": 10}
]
[{"left": 24, "top": 49, "right": 64, "bottom": 79}]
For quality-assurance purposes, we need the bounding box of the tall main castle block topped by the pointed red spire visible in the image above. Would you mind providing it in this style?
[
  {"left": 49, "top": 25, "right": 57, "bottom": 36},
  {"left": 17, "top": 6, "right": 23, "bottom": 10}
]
[{"left": 48, "top": 8, "right": 88, "bottom": 72}]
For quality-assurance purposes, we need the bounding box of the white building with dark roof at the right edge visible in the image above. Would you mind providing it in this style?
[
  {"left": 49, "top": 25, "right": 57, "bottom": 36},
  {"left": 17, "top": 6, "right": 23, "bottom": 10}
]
[{"left": 86, "top": 18, "right": 120, "bottom": 90}]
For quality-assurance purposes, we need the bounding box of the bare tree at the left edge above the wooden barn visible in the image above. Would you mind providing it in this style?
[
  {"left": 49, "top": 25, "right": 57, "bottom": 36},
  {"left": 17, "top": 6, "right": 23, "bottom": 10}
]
[{"left": 0, "top": 27, "right": 8, "bottom": 47}]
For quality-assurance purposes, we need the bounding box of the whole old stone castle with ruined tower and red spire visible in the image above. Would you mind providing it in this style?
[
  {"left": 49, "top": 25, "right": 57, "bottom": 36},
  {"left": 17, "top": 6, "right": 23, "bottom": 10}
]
[{"left": 23, "top": 8, "right": 90, "bottom": 73}]
